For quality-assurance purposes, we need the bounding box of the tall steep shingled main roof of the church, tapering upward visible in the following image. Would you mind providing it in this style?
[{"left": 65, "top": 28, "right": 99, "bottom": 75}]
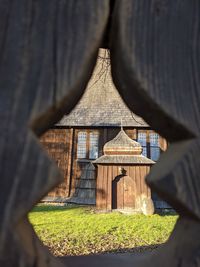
[{"left": 58, "top": 49, "right": 148, "bottom": 127}]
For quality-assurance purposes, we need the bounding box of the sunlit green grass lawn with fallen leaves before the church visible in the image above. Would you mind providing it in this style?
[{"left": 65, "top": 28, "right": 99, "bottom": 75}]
[{"left": 29, "top": 205, "right": 177, "bottom": 256}]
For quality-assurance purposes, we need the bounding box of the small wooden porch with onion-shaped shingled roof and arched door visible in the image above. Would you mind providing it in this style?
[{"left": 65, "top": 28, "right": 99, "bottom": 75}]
[{"left": 93, "top": 129, "right": 154, "bottom": 214}]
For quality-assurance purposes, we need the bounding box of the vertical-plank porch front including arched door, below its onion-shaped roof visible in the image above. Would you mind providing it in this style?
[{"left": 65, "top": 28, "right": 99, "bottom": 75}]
[{"left": 95, "top": 163, "right": 151, "bottom": 213}]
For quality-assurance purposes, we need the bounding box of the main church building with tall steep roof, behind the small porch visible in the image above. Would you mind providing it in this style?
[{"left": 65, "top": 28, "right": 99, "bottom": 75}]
[{"left": 40, "top": 49, "right": 167, "bottom": 211}]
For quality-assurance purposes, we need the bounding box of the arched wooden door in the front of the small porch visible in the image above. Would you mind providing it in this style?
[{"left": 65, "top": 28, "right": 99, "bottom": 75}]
[{"left": 112, "top": 175, "right": 135, "bottom": 209}]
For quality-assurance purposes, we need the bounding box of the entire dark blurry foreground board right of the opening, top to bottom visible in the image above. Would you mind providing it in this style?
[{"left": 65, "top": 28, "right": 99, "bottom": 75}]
[{"left": 111, "top": 0, "right": 200, "bottom": 267}]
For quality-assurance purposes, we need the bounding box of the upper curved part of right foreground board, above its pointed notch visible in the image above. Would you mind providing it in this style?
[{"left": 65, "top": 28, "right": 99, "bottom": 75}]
[{"left": 111, "top": 0, "right": 200, "bottom": 141}]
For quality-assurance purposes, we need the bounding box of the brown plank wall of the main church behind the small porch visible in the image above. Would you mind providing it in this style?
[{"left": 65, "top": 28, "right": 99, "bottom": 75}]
[{"left": 40, "top": 127, "right": 167, "bottom": 205}]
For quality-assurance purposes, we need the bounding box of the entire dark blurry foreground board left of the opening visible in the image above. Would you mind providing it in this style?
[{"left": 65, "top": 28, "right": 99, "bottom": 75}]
[{"left": 0, "top": 0, "right": 109, "bottom": 267}]
